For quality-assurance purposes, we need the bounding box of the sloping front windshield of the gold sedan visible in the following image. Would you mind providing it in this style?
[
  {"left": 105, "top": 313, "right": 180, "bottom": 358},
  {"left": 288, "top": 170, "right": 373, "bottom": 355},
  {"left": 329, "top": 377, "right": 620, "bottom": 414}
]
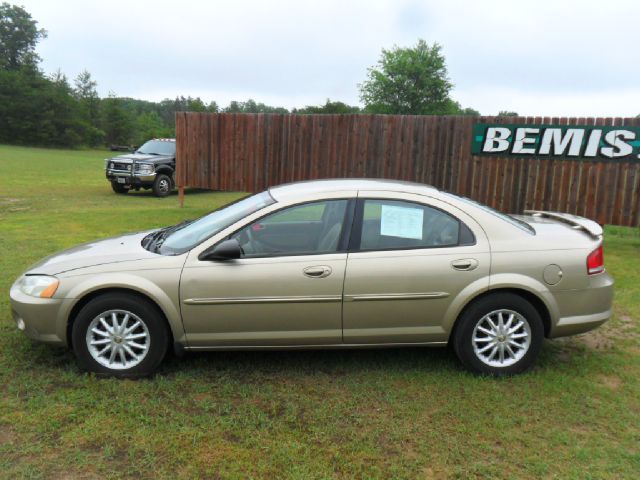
[{"left": 160, "top": 191, "right": 275, "bottom": 255}]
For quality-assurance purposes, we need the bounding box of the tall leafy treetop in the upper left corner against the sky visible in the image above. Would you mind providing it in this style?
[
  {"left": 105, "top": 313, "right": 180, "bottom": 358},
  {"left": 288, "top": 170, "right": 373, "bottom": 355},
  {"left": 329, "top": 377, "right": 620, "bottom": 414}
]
[{"left": 0, "top": 2, "right": 47, "bottom": 70}]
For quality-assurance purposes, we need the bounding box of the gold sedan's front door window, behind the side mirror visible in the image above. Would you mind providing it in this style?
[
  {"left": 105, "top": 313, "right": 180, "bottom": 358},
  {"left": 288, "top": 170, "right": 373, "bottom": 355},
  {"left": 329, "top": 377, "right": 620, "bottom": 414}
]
[{"left": 230, "top": 200, "right": 348, "bottom": 258}]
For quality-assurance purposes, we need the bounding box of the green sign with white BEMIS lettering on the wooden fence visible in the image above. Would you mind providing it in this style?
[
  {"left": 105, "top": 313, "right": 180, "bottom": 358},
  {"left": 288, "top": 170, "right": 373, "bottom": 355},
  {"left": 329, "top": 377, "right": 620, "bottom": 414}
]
[{"left": 471, "top": 123, "right": 640, "bottom": 162}]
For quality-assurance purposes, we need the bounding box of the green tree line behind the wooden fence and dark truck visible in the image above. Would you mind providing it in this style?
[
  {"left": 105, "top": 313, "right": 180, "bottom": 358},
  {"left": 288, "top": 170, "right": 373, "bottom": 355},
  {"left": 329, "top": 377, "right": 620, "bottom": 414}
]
[{"left": 0, "top": 3, "right": 500, "bottom": 147}]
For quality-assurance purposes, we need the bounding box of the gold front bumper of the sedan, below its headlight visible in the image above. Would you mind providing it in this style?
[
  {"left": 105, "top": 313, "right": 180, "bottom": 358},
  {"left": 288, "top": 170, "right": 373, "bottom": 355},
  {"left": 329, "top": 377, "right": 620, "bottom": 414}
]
[{"left": 9, "top": 286, "right": 68, "bottom": 346}]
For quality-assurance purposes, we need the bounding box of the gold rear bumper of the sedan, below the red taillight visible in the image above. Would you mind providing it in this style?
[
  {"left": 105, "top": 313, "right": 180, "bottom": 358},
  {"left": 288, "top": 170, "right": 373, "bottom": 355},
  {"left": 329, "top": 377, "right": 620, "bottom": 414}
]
[{"left": 549, "top": 272, "right": 614, "bottom": 338}]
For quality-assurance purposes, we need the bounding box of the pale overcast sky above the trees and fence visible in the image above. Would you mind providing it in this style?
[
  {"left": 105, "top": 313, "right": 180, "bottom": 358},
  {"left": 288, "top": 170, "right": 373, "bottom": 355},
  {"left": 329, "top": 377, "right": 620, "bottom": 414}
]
[{"left": 17, "top": 0, "right": 640, "bottom": 116}]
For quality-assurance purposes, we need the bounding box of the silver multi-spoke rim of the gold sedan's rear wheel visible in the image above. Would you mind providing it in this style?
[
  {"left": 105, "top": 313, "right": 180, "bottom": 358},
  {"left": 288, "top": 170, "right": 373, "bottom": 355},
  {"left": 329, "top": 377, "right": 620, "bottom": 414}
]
[{"left": 471, "top": 309, "right": 531, "bottom": 368}]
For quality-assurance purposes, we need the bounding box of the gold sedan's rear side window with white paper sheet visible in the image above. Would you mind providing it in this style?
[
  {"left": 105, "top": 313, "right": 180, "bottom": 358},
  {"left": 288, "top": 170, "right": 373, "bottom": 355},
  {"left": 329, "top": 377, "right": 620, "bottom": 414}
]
[{"left": 360, "top": 199, "right": 475, "bottom": 250}]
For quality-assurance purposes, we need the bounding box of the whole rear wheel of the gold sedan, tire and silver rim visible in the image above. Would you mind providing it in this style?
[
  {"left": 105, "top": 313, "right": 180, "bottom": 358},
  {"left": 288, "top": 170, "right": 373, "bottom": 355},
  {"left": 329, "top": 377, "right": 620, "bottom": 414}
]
[{"left": 453, "top": 293, "right": 544, "bottom": 376}]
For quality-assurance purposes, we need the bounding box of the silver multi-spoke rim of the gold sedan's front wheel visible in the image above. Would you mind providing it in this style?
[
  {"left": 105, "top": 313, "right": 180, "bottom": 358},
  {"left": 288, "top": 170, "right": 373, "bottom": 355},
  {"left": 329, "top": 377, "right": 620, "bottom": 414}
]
[{"left": 86, "top": 310, "right": 151, "bottom": 370}]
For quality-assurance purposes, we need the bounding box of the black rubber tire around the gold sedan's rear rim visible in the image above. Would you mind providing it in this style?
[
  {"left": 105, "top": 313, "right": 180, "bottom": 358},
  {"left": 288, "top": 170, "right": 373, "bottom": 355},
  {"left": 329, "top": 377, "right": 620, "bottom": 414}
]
[{"left": 452, "top": 293, "right": 544, "bottom": 376}]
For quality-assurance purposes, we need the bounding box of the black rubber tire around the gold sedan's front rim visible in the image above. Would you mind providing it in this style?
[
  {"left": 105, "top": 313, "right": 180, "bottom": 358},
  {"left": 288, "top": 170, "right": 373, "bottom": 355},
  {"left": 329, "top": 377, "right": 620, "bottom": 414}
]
[{"left": 71, "top": 293, "right": 170, "bottom": 378}]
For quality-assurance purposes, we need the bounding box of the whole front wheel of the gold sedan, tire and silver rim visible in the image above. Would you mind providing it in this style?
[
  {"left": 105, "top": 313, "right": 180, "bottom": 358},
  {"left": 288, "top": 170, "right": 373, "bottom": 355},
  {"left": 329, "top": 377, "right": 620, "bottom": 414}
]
[{"left": 72, "top": 293, "right": 169, "bottom": 378}]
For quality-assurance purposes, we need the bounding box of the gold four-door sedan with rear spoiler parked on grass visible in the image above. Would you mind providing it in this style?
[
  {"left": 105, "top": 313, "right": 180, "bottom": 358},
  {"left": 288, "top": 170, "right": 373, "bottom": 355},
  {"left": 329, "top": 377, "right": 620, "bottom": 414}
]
[{"left": 10, "top": 179, "right": 613, "bottom": 377}]
